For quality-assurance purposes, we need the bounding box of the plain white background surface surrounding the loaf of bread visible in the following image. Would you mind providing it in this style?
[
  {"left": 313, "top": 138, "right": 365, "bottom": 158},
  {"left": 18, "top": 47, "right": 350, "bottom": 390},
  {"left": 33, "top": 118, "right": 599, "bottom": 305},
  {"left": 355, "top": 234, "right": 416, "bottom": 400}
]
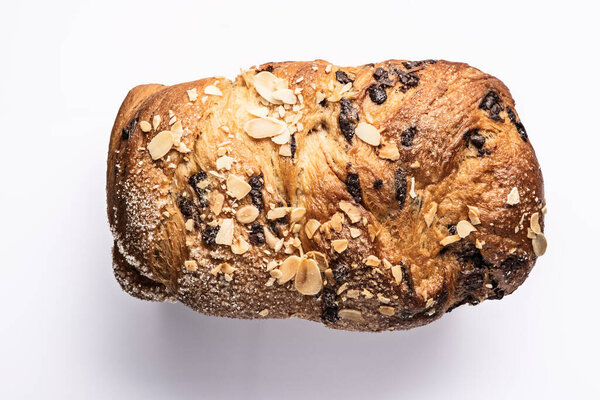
[{"left": 0, "top": 0, "right": 600, "bottom": 399}]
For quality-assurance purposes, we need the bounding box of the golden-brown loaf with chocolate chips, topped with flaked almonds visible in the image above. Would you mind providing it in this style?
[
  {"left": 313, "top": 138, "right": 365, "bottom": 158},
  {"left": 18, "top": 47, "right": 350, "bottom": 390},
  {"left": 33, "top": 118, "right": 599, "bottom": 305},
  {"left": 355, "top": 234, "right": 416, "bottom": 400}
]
[{"left": 107, "top": 60, "right": 546, "bottom": 331}]
